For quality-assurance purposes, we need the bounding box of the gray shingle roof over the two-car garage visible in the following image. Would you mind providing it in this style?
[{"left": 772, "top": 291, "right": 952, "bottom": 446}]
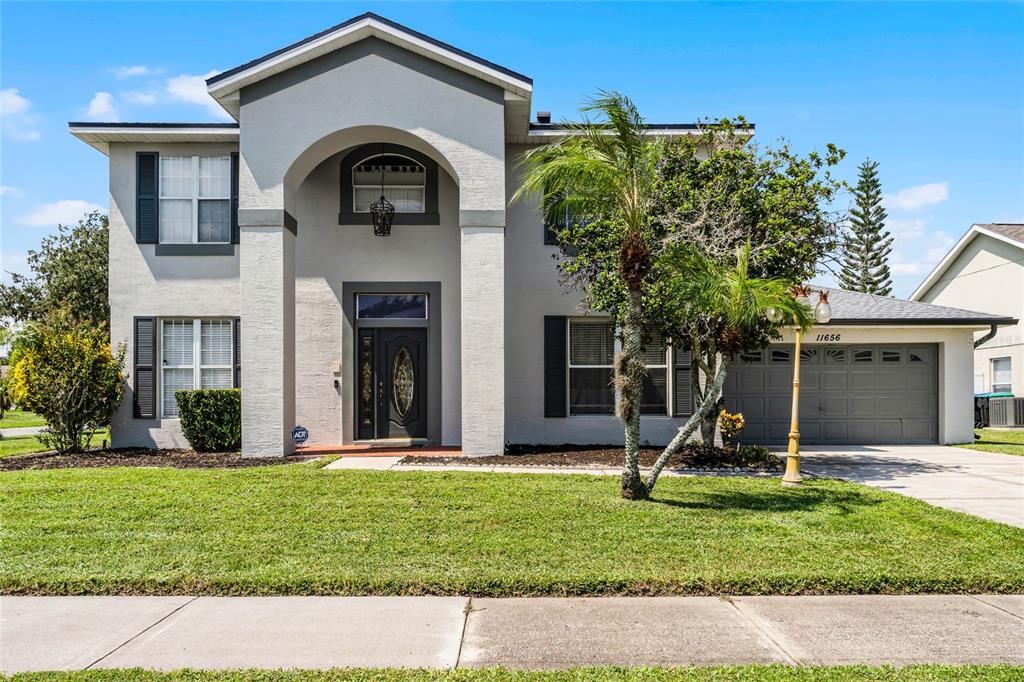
[{"left": 811, "top": 287, "right": 1017, "bottom": 326}]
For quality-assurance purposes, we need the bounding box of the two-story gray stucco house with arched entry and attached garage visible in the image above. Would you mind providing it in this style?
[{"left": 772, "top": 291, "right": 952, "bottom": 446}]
[{"left": 71, "top": 14, "right": 1006, "bottom": 456}]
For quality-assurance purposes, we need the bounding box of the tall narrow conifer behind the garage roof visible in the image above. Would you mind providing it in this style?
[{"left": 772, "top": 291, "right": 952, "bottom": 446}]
[{"left": 839, "top": 159, "right": 893, "bottom": 296}]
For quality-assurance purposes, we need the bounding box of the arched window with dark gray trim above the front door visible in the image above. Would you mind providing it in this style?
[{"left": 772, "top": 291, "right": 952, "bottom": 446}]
[{"left": 338, "top": 143, "right": 439, "bottom": 225}]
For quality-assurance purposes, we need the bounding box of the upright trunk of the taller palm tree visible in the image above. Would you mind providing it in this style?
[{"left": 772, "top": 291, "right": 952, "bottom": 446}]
[{"left": 615, "top": 290, "right": 647, "bottom": 500}]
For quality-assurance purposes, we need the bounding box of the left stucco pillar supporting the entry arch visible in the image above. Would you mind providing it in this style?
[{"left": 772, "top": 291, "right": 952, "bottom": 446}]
[{"left": 239, "top": 208, "right": 296, "bottom": 450}]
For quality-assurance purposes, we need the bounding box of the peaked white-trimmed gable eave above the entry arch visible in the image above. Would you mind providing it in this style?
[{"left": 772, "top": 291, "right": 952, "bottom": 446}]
[{"left": 206, "top": 12, "right": 534, "bottom": 118}]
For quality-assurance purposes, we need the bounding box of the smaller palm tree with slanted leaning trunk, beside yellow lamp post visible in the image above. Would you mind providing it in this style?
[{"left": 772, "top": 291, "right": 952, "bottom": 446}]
[{"left": 644, "top": 244, "right": 814, "bottom": 495}]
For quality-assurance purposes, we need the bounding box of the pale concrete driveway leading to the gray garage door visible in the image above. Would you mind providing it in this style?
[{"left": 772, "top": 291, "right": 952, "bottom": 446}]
[{"left": 801, "top": 445, "right": 1024, "bottom": 527}]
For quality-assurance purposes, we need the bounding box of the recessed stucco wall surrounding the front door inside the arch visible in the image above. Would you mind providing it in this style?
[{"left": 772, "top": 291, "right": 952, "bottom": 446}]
[{"left": 295, "top": 152, "right": 461, "bottom": 444}]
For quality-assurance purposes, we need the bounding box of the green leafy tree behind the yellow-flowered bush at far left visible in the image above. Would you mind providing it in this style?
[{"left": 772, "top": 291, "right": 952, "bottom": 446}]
[{"left": 0, "top": 211, "right": 111, "bottom": 325}]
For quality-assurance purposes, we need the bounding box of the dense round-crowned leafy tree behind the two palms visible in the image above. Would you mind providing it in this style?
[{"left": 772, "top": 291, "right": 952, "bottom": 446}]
[{"left": 648, "top": 118, "right": 845, "bottom": 444}]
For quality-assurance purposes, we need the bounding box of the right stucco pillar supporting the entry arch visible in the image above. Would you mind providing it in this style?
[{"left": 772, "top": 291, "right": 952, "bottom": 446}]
[{"left": 459, "top": 210, "right": 505, "bottom": 456}]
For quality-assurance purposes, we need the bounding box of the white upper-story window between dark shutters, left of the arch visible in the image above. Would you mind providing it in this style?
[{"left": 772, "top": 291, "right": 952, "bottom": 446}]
[{"left": 160, "top": 155, "right": 231, "bottom": 244}]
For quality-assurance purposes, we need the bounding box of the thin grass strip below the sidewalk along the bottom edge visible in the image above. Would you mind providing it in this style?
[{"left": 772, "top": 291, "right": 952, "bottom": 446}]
[{"left": 0, "top": 666, "right": 1021, "bottom": 682}]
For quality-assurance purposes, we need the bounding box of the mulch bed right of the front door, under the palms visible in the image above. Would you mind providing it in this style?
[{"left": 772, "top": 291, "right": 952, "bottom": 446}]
[{"left": 400, "top": 444, "right": 782, "bottom": 471}]
